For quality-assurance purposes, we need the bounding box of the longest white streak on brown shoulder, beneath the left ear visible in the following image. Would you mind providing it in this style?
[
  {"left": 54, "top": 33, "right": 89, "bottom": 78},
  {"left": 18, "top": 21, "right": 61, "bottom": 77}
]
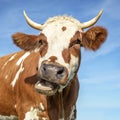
[{"left": 11, "top": 52, "right": 30, "bottom": 87}]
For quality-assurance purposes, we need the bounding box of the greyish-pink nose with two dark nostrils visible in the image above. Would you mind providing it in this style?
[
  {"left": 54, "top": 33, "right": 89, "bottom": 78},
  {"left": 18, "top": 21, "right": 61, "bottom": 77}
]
[{"left": 40, "top": 63, "right": 67, "bottom": 84}]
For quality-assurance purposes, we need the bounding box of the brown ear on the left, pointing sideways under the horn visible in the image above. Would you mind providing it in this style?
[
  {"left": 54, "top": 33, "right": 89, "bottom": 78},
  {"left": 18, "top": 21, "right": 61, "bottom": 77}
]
[{"left": 12, "top": 33, "right": 39, "bottom": 51}]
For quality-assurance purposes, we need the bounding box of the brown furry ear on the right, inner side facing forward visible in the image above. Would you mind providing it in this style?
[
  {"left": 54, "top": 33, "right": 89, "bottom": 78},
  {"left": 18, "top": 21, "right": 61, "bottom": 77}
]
[{"left": 82, "top": 26, "right": 107, "bottom": 51}]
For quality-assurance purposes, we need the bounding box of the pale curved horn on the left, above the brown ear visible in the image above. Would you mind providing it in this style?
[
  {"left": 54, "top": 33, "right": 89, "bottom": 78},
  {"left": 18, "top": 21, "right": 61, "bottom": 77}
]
[{"left": 23, "top": 11, "right": 43, "bottom": 30}]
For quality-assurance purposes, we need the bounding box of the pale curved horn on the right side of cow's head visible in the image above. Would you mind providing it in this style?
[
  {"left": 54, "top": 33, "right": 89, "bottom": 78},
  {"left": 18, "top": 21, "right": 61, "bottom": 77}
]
[{"left": 81, "top": 10, "right": 103, "bottom": 28}]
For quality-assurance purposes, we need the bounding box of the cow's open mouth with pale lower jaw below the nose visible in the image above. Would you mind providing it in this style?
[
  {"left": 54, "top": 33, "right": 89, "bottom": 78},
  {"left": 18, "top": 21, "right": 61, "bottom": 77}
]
[{"left": 35, "top": 78, "right": 59, "bottom": 96}]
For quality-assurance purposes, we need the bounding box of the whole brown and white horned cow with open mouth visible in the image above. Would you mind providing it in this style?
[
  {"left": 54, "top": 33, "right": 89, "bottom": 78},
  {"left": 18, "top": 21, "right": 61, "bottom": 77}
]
[{"left": 0, "top": 11, "right": 107, "bottom": 120}]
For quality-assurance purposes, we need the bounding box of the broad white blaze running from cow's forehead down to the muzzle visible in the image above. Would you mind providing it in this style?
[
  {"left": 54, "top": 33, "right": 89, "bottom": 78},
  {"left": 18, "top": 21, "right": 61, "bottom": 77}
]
[{"left": 39, "top": 19, "right": 81, "bottom": 70}]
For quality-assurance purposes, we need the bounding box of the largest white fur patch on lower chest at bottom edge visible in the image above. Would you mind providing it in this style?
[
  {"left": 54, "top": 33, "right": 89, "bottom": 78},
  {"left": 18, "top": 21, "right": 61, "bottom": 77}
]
[{"left": 24, "top": 107, "right": 39, "bottom": 120}]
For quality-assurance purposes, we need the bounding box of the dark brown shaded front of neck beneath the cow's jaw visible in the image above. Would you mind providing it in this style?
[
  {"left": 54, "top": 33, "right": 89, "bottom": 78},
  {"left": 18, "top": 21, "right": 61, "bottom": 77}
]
[{"left": 47, "top": 76, "right": 79, "bottom": 120}]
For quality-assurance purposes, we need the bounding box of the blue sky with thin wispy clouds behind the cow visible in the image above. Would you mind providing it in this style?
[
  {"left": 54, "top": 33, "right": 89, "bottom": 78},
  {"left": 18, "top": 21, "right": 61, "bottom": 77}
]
[{"left": 0, "top": 0, "right": 120, "bottom": 120}]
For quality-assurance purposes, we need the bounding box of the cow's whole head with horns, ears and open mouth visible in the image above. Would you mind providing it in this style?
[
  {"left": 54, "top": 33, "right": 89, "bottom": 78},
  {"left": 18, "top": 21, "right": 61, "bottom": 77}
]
[{"left": 12, "top": 11, "right": 107, "bottom": 95}]
